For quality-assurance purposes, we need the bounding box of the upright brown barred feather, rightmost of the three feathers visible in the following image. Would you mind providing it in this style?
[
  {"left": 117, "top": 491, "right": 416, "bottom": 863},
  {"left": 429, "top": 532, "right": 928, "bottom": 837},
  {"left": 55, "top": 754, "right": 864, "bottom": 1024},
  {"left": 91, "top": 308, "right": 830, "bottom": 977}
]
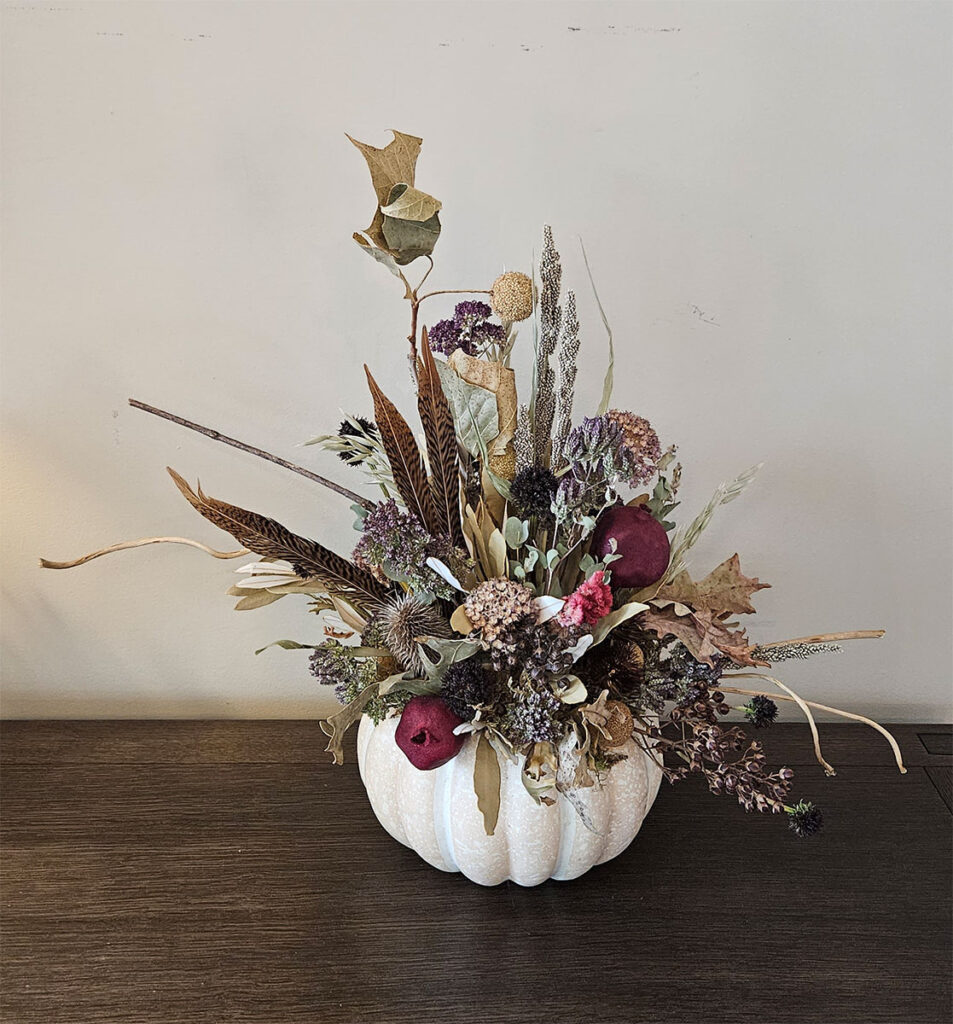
[{"left": 417, "top": 328, "right": 464, "bottom": 548}]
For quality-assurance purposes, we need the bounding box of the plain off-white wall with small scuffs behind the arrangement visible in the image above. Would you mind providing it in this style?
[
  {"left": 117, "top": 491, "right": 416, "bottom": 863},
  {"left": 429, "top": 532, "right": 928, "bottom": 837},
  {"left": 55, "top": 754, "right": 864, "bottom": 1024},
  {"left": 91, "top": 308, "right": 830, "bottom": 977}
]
[{"left": 2, "top": 0, "right": 953, "bottom": 721}]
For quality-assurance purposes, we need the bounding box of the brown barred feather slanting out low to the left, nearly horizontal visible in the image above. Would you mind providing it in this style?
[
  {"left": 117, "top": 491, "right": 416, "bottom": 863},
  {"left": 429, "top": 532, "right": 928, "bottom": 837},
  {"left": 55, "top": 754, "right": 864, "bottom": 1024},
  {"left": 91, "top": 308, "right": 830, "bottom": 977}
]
[{"left": 166, "top": 467, "right": 388, "bottom": 602}]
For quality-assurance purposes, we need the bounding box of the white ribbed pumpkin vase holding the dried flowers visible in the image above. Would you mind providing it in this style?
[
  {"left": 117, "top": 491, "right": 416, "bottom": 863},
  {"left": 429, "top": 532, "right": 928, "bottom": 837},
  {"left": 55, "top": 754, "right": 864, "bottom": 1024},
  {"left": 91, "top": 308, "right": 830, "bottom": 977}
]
[{"left": 357, "top": 716, "right": 662, "bottom": 886}]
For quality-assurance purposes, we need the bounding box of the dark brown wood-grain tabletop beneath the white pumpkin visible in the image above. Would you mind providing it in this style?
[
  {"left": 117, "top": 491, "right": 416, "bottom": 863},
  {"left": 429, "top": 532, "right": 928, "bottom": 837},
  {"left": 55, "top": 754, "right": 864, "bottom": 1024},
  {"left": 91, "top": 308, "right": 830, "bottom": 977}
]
[{"left": 0, "top": 722, "right": 953, "bottom": 1024}]
